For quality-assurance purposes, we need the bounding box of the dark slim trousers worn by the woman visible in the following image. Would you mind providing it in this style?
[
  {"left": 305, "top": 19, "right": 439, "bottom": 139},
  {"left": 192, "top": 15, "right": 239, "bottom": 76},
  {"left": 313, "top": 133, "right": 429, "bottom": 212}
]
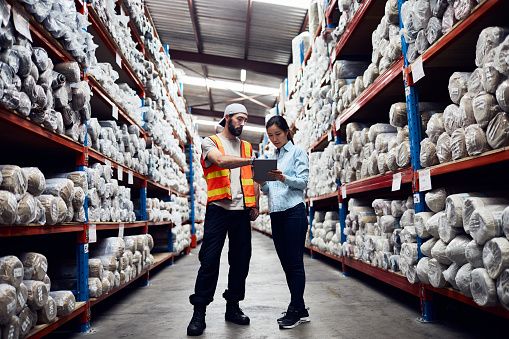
[{"left": 270, "top": 203, "right": 308, "bottom": 309}]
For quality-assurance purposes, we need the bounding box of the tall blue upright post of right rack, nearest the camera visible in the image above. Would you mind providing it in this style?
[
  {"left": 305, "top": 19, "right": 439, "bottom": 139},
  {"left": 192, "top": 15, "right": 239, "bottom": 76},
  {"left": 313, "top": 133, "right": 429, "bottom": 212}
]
[{"left": 398, "top": 0, "right": 433, "bottom": 322}]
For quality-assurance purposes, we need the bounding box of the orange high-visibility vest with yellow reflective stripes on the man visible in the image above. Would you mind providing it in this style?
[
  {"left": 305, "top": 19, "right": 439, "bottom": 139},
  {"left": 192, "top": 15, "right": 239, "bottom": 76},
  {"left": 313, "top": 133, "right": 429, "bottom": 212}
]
[{"left": 201, "top": 135, "right": 256, "bottom": 208}]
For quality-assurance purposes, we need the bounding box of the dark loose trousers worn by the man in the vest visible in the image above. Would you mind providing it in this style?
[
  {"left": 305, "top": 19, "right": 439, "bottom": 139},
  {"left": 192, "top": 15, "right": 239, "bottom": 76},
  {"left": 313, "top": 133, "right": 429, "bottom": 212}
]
[{"left": 189, "top": 205, "right": 251, "bottom": 306}]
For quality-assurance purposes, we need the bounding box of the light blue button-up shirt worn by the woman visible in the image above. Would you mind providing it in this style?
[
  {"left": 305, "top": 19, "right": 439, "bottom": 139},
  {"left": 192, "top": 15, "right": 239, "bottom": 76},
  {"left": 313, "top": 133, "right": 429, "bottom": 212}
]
[{"left": 261, "top": 141, "right": 309, "bottom": 213}]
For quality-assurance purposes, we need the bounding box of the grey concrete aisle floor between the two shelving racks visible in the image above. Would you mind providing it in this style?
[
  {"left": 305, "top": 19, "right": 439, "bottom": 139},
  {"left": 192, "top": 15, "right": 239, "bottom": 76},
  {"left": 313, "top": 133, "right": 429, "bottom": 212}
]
[{"left": 53, "top": 232, "right": 508, "bottom": 339}]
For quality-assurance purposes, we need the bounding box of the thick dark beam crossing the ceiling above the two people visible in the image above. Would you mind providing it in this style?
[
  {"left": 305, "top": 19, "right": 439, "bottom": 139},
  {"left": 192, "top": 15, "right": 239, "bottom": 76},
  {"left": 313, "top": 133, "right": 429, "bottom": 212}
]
[{"left": 170, "top": 50, "right": 288, "bottom": 78}]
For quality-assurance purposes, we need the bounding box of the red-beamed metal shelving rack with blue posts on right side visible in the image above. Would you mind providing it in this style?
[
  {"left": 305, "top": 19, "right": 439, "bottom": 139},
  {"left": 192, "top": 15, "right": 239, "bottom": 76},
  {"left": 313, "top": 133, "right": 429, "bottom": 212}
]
[{"left": 261, "top": 0, "right": 509, "bottom": 322}]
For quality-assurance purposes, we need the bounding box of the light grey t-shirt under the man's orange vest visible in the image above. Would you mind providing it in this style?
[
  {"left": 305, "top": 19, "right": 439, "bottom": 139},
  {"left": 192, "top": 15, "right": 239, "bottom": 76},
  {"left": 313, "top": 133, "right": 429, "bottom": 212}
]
[{"left": 201, "top": 134, "right": 244, "bottom": 210}]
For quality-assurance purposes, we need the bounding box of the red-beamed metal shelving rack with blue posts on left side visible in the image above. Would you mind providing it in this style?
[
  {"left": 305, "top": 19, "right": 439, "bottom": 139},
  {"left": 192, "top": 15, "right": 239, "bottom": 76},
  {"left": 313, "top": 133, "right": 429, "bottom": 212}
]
[{"left": 0, "top": 0, "right": 192, "bottom": 338}]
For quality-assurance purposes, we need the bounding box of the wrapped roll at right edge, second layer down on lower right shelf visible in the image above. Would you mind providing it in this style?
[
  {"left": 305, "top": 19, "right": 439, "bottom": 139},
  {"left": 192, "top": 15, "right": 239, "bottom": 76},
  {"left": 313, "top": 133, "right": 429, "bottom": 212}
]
[{"left": 482, "top": 238, "right": 509, "bottom": 279}]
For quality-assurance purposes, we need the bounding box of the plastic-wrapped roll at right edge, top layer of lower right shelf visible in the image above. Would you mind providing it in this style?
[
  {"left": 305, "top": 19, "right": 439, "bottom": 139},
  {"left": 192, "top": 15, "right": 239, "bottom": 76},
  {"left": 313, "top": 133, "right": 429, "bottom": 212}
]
[{"left": 469, "top": 205, "right": 506, "bottom": 245}]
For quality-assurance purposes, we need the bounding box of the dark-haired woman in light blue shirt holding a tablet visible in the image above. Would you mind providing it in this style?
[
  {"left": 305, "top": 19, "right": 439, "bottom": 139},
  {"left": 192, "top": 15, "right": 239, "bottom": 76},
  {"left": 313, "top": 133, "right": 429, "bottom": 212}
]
[{"left": 261, "top": 116, "right": 309, "bottom": 329}]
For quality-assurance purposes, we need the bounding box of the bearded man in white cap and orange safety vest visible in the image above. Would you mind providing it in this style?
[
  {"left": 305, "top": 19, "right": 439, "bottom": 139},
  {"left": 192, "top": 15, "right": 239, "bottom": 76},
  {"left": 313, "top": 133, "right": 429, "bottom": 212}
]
[{"left": 187, "top": 104, "right": 259, "bottom": 336}]
